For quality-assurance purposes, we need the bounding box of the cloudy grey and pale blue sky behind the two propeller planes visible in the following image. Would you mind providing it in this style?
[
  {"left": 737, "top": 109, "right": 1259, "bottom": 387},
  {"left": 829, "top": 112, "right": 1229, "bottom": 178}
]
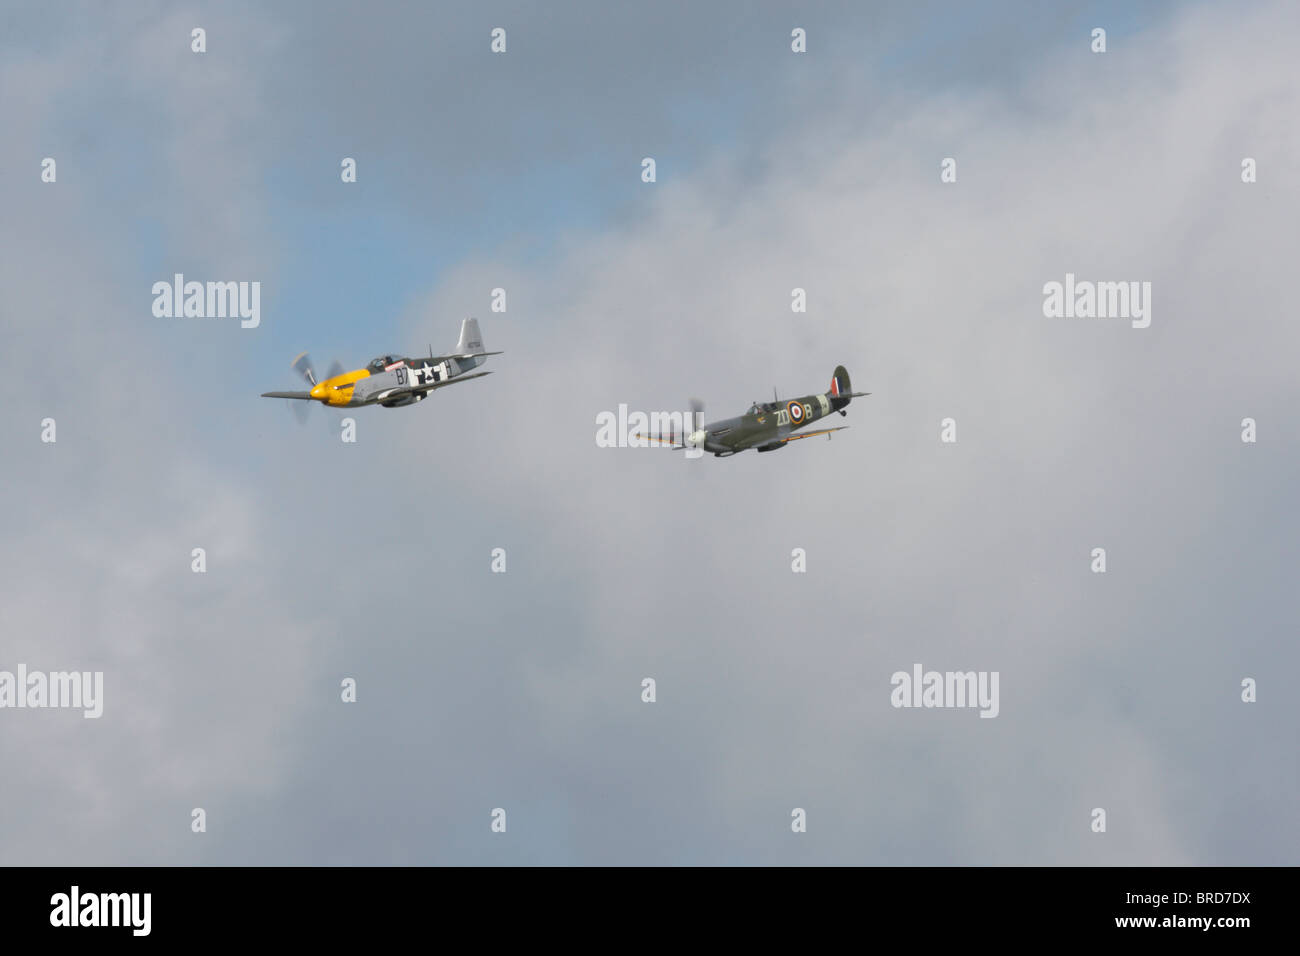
[{"left": 0, "top": 3, "right": 1300, "bottom": 866}]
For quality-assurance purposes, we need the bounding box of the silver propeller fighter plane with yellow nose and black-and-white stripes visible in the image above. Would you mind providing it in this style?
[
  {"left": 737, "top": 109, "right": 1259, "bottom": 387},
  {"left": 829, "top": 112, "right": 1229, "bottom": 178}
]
[{"left": 261, "top": 319, "right": 502, "bottom": 408}]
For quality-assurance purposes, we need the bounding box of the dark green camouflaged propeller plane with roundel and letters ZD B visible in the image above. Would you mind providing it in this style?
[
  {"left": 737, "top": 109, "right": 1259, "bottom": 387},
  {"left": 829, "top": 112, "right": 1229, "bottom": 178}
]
[{"left": 637, "top": 365, "right": 871, "bottom": 458}]
